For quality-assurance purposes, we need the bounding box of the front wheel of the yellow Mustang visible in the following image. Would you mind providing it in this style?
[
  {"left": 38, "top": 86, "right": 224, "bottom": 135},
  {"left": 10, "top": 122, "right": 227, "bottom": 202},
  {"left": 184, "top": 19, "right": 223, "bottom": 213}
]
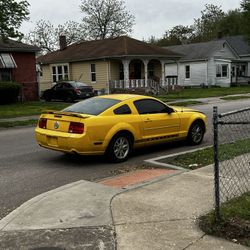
[{"left": 187, "top": 121, "right": 205, "bottom": 145}]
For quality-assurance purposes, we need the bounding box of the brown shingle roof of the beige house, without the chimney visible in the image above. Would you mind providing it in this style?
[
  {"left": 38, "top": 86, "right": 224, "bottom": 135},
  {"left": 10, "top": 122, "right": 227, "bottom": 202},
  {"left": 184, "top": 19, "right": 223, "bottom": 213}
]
[{"left": 38, "top": 36, "right": 181, "bottom": 64}]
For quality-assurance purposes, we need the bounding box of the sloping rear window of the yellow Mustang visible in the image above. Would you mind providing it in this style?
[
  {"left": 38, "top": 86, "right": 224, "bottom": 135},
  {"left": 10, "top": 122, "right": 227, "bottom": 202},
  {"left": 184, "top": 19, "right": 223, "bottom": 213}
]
[{"left": 63, "top": 98, "right": 120, "bottom": 115}]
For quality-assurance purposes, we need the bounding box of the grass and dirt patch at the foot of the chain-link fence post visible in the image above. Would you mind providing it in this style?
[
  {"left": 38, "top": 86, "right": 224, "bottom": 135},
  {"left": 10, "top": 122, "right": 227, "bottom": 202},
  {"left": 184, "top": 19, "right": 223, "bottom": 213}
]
[{"left": 199, "top": 192, "right": 250, "bottom": 247}]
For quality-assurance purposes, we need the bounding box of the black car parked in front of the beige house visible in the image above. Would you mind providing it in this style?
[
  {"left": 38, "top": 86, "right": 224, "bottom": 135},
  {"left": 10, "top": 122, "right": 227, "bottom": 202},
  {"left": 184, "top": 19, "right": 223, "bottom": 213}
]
[{"left": 42, "top": 81, "right": 94, "bottom": 102}]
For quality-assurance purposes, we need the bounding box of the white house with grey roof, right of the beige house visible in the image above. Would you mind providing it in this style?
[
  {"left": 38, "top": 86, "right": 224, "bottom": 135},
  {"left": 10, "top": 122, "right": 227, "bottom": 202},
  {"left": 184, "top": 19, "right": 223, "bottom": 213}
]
[{"left": 165, "top": 36, "right": 250, "bottom": 87}]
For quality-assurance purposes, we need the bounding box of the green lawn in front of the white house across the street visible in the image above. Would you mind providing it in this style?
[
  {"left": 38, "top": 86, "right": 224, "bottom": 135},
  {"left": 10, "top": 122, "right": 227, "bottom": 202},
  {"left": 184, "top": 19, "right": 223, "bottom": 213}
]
[{"left": 157, "top": 86, "right": 250, "bottom": 102}]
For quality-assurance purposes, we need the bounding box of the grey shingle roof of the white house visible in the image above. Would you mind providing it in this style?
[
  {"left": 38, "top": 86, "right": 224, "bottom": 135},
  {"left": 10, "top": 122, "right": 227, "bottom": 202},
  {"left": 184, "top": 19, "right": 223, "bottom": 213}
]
[{"left": 164, "top": 36, "right": 250, "bottom": 61}]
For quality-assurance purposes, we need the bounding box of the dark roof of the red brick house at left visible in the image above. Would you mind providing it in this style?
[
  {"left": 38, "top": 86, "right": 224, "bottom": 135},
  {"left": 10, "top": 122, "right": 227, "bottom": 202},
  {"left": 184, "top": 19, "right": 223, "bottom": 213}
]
[{"left": 0, "top": 39, "right": 40, "bottom": 52}]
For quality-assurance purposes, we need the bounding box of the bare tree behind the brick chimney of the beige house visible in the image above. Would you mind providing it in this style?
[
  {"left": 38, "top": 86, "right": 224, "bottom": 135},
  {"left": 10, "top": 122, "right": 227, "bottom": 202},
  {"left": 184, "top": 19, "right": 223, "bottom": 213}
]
[{"left": 24, "top": 20, "right": 86, "bottom": 54}]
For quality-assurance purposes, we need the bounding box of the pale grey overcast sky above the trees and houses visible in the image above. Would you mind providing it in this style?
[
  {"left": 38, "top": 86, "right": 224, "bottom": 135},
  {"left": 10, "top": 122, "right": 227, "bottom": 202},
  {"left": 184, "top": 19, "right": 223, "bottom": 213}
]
[{"left": 21, "top": 0, "right": 240, "bottom": 40}]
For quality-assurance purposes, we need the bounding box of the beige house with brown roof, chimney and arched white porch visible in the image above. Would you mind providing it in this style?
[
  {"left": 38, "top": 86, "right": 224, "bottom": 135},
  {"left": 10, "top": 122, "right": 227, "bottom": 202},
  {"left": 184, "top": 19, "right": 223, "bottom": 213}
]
[{"left": 37, "top": 36, "right": 181, "bottom": 92}]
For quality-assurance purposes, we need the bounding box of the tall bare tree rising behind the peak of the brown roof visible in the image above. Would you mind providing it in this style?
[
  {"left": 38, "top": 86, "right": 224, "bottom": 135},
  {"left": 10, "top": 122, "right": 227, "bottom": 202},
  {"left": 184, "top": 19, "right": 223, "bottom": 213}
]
[{"left": 80, "top": 0, "right": 135, "bottom": 39}]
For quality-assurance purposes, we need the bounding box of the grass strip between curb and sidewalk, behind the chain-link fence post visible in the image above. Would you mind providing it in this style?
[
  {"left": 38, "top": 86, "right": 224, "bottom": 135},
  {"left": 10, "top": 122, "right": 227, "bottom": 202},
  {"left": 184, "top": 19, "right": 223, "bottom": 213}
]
[{"left": 161, "top": 139, "right": 250, "bottom": 169}]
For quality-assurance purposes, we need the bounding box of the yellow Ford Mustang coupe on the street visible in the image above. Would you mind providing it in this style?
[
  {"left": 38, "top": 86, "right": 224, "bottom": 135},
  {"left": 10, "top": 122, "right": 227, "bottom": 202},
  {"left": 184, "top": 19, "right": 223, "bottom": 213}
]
[{"left": 36, "top": 94, "right": 206, "bottom": 162}]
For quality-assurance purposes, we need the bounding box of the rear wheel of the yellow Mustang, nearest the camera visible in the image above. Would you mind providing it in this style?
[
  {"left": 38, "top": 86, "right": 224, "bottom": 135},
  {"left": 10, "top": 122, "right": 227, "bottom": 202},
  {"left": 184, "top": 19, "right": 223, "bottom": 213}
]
[{"left": 106, "top": 133, "right": 132, "bottom": 163}]
